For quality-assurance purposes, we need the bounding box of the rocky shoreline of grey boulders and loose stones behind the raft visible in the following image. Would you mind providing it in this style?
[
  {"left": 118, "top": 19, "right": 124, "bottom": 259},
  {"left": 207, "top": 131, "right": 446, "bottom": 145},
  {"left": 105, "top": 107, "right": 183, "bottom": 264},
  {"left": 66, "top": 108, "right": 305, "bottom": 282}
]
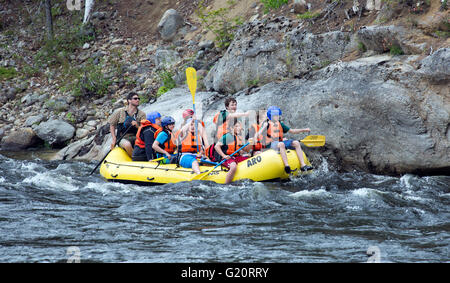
[{"left": 0, "top": 0, "right": 450, "bottom": 178}]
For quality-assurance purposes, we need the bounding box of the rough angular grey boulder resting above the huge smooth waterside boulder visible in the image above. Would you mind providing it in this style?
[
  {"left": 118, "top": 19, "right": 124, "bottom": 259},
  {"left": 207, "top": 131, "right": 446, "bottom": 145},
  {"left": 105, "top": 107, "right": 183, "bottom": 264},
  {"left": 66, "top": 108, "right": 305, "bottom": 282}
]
[{"left": 205, "top": 18, "right": 357, "bottom": 93}]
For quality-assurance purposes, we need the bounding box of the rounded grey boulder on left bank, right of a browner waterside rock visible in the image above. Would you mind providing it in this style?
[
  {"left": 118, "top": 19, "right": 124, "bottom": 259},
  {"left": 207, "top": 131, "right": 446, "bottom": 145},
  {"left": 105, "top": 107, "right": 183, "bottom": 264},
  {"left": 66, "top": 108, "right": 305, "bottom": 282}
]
[{"left": 34, "top": 120, "right": 75, "bottom": 145}]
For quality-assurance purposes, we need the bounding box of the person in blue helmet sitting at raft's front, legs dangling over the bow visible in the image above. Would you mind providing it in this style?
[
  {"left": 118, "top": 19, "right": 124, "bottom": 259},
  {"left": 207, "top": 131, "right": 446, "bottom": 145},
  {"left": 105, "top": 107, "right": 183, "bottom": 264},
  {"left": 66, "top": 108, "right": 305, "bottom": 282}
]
[{"left": 254, "top": 106, "right": 313, "bottom": 174}]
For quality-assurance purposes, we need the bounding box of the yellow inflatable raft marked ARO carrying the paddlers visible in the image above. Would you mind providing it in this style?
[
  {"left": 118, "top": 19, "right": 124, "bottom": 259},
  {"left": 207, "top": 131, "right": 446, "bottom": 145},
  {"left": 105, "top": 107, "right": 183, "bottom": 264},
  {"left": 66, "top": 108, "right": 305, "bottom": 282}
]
[{"left": 100, "top": 147, "right": 311, "bottom": 184}]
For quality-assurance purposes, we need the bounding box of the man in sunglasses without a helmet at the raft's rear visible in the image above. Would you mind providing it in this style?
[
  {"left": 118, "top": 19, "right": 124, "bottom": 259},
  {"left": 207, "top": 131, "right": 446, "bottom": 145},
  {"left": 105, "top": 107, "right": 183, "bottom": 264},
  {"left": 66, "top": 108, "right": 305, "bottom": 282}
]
[{"left": 108, "top": 92, "right": 146, "bottom": 156}]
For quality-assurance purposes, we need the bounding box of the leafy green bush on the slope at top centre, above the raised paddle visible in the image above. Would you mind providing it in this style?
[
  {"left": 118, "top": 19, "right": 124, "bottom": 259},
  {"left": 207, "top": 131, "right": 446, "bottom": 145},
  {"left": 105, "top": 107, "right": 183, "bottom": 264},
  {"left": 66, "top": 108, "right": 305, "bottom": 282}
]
[{"left": 195, "top": 0, "right": 243, "bottom": 48}]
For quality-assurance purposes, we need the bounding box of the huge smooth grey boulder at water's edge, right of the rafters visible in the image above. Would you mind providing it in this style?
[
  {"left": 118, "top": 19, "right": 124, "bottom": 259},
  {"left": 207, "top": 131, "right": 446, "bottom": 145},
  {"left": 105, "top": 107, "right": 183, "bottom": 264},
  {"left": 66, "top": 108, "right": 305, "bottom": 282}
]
[{"left": 203, "top": 49, "right": 450, "bottom": 174}]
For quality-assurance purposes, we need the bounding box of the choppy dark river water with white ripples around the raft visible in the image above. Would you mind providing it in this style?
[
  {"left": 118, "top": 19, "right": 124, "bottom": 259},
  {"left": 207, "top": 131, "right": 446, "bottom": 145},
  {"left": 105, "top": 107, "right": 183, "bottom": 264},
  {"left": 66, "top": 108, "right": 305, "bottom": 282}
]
[{"left": 0, "top": 153, "right": 450, "bottom": 263}]
